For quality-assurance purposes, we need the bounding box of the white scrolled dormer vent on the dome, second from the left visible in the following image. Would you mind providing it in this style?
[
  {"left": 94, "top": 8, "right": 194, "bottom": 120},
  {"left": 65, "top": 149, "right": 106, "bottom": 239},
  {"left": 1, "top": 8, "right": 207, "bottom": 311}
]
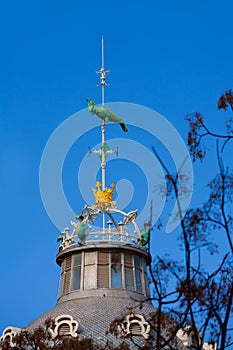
[{"left": 49, "top": 315, "right": 79, "bottom": 339}]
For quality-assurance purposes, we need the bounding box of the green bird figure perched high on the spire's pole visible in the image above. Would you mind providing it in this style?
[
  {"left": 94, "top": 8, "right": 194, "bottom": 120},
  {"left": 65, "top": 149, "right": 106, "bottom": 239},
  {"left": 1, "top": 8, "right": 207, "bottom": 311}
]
[{"left": 87, "top": 99, "right": 128, "bottom": 132}]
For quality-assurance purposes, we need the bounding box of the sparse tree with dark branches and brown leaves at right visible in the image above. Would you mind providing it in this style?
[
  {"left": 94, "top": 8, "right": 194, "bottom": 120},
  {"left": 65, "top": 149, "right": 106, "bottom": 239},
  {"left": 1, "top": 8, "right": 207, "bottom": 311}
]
[{"left": 151, "top": 90, "right": 233, "bottom": 350}]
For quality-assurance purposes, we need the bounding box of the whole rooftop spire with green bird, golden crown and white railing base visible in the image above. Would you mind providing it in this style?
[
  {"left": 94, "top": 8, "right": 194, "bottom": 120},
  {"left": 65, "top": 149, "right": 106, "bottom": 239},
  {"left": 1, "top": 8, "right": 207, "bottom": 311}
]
[{"left": 58, "top": 37, "right": 149, "bottom": 250}]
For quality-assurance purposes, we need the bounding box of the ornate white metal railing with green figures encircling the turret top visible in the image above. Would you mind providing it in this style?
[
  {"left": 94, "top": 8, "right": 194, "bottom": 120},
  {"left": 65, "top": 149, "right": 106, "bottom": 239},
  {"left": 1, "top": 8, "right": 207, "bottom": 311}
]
[{"left": 58, "top": 206, "right": 150, "bottom": 251}]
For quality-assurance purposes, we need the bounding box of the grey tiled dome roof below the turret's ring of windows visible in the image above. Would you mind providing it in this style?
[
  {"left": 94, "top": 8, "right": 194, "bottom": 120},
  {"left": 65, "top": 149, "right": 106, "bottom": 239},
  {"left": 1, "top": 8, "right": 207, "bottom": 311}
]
[{"left": 26, "top": 289, "right": 158, "bottom": 346}]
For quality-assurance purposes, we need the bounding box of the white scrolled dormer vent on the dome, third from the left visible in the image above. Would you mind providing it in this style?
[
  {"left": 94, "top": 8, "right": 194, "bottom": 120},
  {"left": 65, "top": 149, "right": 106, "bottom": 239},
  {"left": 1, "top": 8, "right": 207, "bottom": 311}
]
[{"left": 118, "top": 314, "right": 150, "bottom": 339}]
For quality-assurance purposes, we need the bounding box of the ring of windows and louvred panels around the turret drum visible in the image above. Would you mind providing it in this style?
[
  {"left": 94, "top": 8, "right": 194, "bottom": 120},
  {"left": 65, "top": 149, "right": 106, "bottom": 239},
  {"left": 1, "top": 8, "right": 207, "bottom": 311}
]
[{"left": 59, "top": 250, "right": 149, "bottom": 297}]
